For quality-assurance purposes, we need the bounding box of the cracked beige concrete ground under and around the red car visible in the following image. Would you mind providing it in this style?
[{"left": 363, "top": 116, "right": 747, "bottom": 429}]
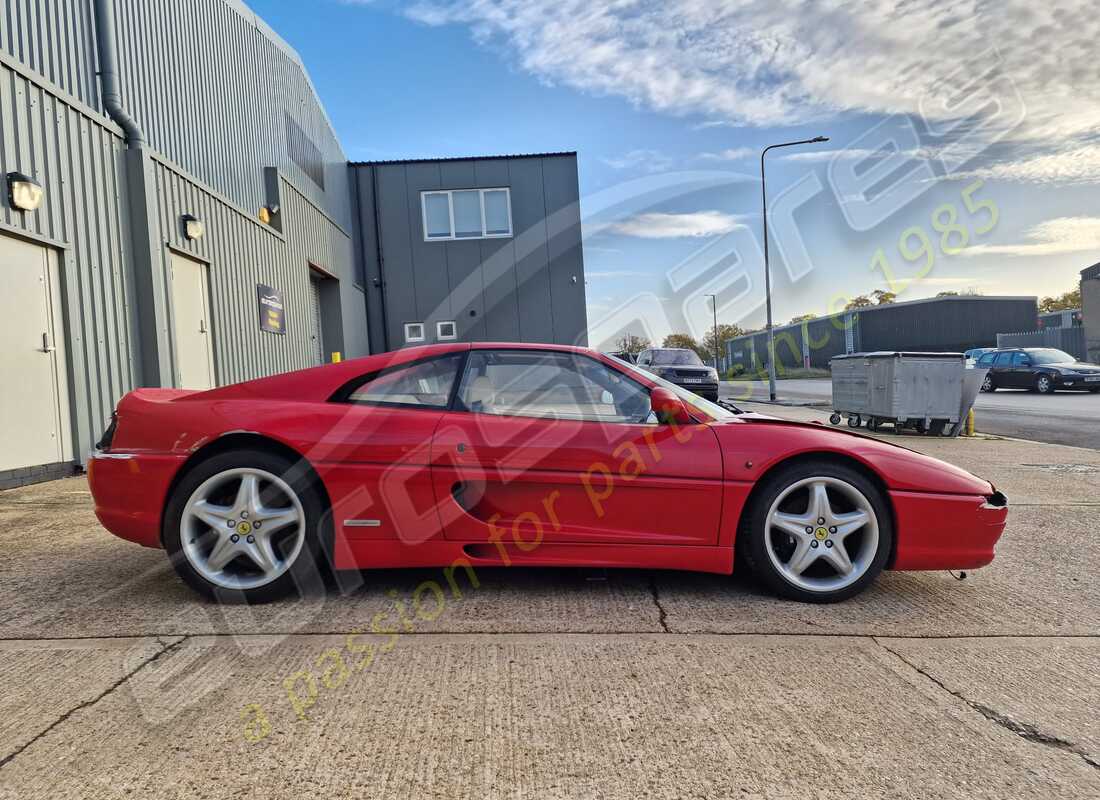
[{"left": 0, "top": 406, "right": 1100, "bottom": 799}]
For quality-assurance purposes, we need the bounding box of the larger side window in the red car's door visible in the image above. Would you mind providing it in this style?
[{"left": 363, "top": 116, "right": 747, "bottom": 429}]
[{"left": 459, "top": 350, "right": 650, "bottom": 423}]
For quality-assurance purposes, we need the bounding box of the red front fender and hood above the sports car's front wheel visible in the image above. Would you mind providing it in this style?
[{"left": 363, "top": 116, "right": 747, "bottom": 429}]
[{"left": 712, "top": 414, "right": 994, "bottom": 495}]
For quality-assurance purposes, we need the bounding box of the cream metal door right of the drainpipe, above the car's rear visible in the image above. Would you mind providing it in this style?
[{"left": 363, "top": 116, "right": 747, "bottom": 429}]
[{"left": 171, "top": 253, "right": 216, "bottom": 390}]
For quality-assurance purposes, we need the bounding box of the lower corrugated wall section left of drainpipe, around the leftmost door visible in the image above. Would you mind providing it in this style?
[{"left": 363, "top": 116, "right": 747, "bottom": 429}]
[{"left": 0, "top": 51, "right": 134, "bottom": 453}]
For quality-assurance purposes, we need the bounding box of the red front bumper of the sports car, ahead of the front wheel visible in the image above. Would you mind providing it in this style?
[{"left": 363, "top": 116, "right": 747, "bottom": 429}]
[{"left": 890, "top": 492, "right": 1009, "bottom": 570}]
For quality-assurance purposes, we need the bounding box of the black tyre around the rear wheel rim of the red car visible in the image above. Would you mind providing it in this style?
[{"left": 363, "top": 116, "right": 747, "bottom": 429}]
[{"left": 161, "top": 450, "right": 332, "bottom": 603}]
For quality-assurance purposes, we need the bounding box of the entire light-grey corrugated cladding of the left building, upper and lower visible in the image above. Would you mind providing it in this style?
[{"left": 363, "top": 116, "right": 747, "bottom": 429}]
[{"left": 0, "top": 0, "right": 369, "bottom": 468}]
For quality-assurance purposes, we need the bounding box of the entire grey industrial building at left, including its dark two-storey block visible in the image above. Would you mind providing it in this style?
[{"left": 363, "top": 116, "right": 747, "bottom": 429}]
[{"left": 0, "top": 0, "right": 587, "bottom": 486}]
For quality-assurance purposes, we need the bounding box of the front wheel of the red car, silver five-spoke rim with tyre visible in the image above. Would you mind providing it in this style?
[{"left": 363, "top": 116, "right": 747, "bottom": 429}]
[{"left": 738, "top": 461, "right": 893, "bottom": 603}]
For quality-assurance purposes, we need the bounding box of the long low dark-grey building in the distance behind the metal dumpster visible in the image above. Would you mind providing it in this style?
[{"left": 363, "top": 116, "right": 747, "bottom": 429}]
[{"left": 726, "top": 296, "right": 1038, "bottom": 371}]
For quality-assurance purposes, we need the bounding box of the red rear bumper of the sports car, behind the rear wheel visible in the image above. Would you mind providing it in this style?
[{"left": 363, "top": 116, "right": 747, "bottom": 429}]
[{"left": 88, "top": 450, "right": 186, "bottom": 547}]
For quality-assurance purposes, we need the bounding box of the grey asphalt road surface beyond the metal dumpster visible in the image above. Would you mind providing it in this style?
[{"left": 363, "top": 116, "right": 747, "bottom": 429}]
[{"left": 721, "top": 379, "right": 1100, "bottom": 448}]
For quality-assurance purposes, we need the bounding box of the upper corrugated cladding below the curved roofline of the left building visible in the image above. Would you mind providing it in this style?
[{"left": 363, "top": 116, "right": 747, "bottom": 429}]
[{"left": 0, "top": 0, "right": 351, "bottom": 228}]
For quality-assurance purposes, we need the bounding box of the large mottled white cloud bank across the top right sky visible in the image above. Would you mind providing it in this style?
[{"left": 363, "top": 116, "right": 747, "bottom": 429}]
[{"left": 405, "top": 0, "right": 1100, "bottom": 180}]
